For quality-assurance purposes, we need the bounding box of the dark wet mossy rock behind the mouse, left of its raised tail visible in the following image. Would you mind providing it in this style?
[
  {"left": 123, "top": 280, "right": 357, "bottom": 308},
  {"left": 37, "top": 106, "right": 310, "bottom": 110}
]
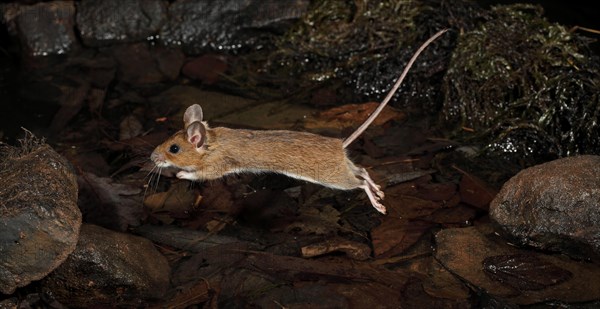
[{"left": 229, "top": 0, "right": 462, "bottom": 103}]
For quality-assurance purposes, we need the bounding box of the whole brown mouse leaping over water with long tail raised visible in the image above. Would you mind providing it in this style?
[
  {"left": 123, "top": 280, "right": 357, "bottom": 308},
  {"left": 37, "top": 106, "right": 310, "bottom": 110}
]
[{"left": 150, "top": 29, "right": 448, "bottom": 214}]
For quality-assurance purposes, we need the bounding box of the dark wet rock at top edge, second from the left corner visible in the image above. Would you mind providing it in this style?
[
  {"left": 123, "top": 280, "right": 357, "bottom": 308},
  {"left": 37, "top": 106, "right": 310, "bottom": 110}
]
[{"left": 76, "top": 0, "right": 167, "bottom": 46}]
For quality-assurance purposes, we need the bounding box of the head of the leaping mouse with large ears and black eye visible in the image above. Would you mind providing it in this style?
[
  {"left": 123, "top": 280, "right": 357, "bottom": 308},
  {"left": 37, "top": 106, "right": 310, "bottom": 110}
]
[{"left": 150, "top": 104, "right": 207, "bottom": 168}]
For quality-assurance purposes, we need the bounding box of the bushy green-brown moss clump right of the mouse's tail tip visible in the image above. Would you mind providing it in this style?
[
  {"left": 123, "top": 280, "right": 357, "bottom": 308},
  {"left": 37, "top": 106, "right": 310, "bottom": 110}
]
[{"left": 443, "top": 4, "right": 600, "bottom": 156}]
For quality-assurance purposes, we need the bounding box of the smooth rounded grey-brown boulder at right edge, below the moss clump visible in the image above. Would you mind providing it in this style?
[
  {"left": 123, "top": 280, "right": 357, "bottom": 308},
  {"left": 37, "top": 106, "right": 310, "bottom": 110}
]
[{"left": 490, "top": 155, "right": 600, "bottom": 259}]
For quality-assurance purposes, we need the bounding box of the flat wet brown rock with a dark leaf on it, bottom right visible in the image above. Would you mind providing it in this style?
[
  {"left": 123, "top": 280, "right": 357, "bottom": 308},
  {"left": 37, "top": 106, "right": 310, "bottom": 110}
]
[{"left": 435, "top": 226, "right": 600, "bottom": 305}]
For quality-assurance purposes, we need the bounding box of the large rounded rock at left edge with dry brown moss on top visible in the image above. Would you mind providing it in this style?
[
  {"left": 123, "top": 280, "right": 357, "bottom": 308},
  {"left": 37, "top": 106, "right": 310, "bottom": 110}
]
[{"left": 0, "top": 137, "right": 81, "bottom": 294}]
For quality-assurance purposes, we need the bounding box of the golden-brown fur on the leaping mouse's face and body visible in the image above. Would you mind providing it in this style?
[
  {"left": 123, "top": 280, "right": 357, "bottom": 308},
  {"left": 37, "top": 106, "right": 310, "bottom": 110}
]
[{"left": 153, "top": 127, "right": 362, "bottom": 190}]
